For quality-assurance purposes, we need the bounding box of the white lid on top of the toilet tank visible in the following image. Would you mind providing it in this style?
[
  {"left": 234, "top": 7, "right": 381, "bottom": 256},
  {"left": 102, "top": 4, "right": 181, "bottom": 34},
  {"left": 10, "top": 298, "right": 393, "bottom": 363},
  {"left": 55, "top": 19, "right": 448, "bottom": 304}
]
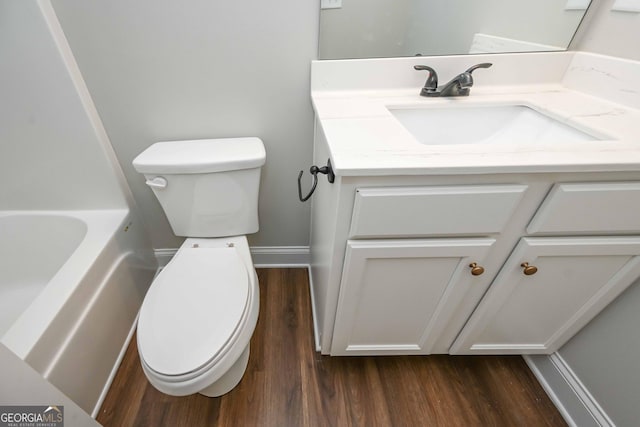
[{"left": 133, "top": 137, "right": 266, "bottom": 174}]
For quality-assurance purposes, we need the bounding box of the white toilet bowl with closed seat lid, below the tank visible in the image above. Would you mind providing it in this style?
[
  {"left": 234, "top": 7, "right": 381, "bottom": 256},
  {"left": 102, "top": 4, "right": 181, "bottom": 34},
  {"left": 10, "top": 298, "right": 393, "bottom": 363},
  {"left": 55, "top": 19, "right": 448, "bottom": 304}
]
[{"left": 137, "top": 236, "right": 259, "bottom": 397}]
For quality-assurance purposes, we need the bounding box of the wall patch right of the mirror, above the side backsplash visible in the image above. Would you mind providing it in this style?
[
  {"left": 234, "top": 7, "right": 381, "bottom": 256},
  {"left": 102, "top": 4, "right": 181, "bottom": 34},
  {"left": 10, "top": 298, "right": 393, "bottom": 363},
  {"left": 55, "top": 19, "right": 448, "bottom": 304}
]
[{"left": 572, "top": 0, "right": 640, "bottom": 61}]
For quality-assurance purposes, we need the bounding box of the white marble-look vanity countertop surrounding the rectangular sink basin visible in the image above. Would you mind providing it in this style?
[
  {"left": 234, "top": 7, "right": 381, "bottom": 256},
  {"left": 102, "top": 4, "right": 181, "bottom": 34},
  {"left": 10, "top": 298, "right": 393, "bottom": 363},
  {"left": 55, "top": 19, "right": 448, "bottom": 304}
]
[{"left": 312, "top": 54, "right": 640, "bottom": 176}]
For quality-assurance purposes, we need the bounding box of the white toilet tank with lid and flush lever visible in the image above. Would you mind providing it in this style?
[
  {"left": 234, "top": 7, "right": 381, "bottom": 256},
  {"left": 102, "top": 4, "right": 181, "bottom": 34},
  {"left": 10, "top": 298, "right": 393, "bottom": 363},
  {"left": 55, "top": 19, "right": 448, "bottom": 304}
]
[{"left": 133, "top": 138, "right": 266, "bottom": 237}]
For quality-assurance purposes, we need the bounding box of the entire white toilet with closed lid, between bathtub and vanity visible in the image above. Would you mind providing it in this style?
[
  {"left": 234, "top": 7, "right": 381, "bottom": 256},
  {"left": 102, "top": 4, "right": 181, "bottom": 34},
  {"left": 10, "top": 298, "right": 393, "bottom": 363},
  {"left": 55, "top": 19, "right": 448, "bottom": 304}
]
[{"left": 133, "top": 138, "right": 265, "bottom": 397}]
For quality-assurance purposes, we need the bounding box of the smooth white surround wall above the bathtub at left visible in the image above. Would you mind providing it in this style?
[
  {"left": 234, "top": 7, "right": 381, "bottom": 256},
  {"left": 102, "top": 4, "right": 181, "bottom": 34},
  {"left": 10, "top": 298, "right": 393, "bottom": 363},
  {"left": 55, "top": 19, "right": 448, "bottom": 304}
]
[{"left": 0, "top": 0, "right": 126, "bottom": 210}]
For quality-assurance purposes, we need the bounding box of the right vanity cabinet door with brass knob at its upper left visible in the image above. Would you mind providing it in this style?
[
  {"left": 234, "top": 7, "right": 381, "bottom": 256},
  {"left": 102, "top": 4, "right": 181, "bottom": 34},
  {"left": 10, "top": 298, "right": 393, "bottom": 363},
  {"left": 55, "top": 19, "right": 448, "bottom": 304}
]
[{"left": 450, "top": 237, "right": 640, "bottom": 354}]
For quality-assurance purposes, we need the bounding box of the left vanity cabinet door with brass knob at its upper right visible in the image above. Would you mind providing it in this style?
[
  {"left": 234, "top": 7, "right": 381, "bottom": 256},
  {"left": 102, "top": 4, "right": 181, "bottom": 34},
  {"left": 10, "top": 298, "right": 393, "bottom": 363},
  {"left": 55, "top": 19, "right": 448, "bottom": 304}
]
[{"left": 331, "top": 239, "right": 494, "bottom": 355}]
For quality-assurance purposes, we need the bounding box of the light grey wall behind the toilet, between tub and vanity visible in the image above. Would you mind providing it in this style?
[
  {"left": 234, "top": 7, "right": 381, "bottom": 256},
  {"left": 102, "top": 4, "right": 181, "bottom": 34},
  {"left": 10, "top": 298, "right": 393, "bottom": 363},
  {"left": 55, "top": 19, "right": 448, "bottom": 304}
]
[{"left": 52, "top": 0, "right": 319, "bottom": 248}]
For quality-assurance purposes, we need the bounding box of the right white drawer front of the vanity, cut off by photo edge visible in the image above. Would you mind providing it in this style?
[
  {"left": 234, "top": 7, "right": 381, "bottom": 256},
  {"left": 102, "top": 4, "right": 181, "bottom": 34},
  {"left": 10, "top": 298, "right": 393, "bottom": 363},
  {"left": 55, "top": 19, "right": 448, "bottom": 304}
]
[{"left": 527, "top": 182, "right": 640, "bottom": 234}]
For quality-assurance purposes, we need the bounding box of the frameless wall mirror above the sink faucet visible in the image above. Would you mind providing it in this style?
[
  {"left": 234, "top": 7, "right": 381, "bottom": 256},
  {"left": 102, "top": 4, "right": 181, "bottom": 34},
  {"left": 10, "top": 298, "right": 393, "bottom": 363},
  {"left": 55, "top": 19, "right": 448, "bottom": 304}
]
[{"left": 319, "top": 0, "right": 590, "bottom": 59}]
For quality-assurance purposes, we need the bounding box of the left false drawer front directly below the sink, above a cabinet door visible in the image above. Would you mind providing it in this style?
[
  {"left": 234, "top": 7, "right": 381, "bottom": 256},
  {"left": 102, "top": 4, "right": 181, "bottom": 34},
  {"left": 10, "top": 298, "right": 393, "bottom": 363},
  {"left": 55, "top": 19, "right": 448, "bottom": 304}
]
[{"left": 349, "top": 184, "right": 527, "bottom": 238}]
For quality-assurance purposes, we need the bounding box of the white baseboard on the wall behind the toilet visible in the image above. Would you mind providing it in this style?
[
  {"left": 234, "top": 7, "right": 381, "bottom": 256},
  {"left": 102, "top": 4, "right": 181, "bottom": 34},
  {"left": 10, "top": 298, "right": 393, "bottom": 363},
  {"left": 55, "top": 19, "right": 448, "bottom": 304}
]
[{"left": 154, "top": 246, "right": 311, "bottom": 268}]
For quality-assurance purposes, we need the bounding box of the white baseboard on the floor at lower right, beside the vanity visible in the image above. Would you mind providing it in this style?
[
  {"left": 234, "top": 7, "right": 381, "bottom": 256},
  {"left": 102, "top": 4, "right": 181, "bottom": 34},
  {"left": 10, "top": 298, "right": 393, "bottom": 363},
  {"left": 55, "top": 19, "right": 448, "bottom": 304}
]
[{"left": 523, "top": 353, "right": 615, "bottom": 427}]
